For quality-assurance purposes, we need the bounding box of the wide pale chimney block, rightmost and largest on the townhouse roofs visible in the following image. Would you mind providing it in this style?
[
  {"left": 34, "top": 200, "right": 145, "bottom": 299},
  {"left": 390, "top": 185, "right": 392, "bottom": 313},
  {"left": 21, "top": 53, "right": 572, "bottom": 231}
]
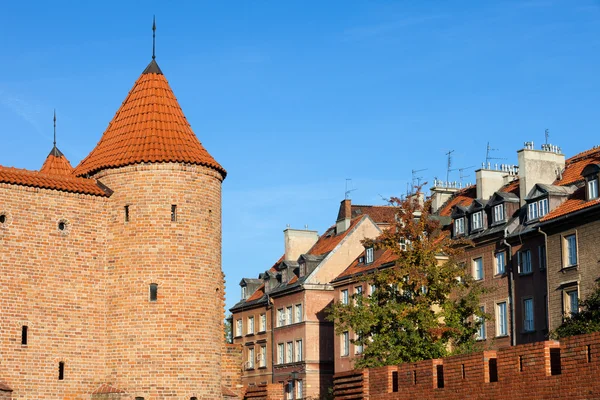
[{"left": 517, "top": 142, "right": 565, "bottom": 205}]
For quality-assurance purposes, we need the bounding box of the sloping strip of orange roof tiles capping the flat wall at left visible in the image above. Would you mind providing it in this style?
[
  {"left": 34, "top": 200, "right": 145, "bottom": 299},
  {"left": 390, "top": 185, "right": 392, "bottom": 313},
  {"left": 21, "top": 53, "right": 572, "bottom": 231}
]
[{"left": 0, "top": 166, "right": 109, "bottom": 197}]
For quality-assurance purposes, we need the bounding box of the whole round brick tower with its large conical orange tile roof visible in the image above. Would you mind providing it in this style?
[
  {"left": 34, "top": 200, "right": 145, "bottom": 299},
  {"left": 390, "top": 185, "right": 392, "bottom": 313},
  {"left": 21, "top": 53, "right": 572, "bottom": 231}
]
[{"left": 74, "top": 59, "right": 226, "bottom": 400}]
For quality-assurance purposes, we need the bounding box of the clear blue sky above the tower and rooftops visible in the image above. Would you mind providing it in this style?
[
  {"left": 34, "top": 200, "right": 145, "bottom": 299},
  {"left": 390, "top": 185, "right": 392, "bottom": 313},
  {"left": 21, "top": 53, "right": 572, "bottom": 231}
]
[{"left": 0, "top": 0, "right": 600, "bottom": 307}]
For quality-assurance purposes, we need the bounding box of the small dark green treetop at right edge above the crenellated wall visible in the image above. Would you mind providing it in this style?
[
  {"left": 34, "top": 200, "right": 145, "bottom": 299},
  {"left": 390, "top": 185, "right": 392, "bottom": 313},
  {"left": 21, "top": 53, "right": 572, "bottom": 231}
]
[{"left": 550, "top": 284, "right": 600, "bottom": 339}]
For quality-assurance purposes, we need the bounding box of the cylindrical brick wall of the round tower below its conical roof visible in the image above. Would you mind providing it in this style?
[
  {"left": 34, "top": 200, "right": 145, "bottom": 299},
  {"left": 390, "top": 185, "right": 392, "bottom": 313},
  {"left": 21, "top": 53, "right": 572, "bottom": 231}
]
[{"left": 95, "top": 163, "right": 224, "bottom": 400}]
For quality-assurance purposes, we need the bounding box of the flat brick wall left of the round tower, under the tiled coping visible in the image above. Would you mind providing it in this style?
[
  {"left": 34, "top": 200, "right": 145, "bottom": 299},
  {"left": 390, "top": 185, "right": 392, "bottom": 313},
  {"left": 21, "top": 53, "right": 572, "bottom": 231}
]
[{"left": 0, "top": 184, "right": 108, "bottom": 399}]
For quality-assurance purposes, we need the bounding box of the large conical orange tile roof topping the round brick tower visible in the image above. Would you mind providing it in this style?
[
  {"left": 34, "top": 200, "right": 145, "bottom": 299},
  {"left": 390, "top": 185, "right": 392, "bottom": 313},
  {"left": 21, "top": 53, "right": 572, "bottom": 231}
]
[{"left": 74, "top": 60, "right": 226, "bottom": 176}]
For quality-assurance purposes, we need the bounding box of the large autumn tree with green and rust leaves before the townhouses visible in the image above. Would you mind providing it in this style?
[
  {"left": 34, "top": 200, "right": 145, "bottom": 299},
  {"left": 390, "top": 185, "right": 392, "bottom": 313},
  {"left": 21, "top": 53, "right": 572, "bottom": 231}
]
[{"left": 328, "top": 190, "right": 484, "bottom": 368}]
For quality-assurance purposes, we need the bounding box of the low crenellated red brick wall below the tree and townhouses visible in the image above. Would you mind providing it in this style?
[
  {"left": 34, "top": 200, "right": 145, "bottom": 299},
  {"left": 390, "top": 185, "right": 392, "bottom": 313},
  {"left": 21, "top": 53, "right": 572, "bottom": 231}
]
[{"left": 334, "top": 333, "right": 600, "bottom": 400}]
